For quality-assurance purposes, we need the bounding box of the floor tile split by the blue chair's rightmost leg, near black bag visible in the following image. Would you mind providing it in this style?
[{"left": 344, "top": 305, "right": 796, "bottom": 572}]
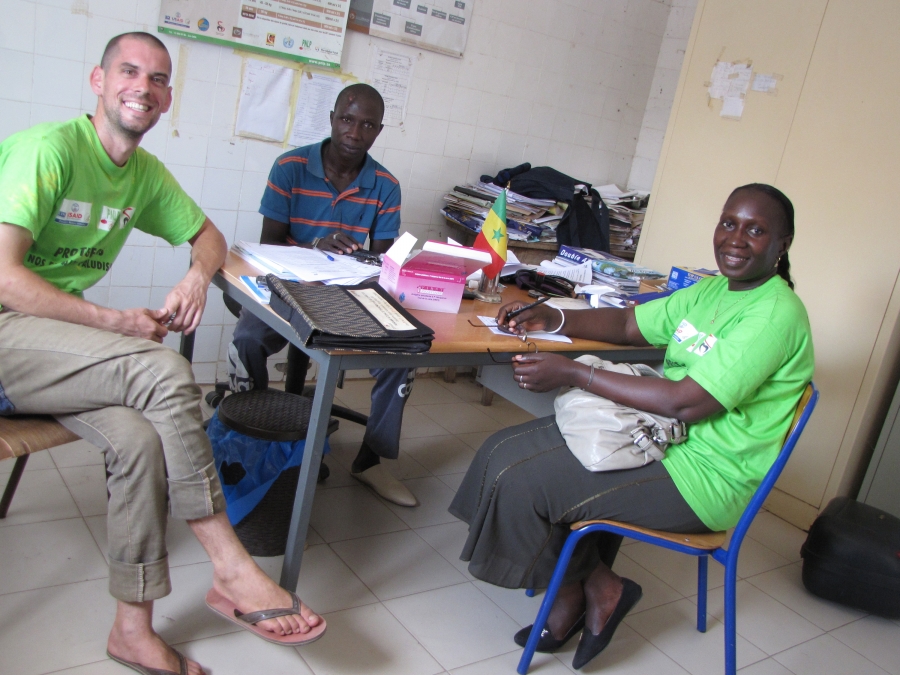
[{"left": 708, "top": 581, "right": 823, "bottom": 655}]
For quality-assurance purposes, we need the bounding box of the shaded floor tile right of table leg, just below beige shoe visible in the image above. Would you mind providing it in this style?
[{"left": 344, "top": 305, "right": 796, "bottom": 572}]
[{"left": 310, "top": 486, "right": 408, "bottom": 543}]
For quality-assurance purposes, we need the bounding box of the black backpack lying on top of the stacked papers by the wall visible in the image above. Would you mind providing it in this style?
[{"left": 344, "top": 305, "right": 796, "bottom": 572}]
[{"left": 481, "top": 164, "right": 609, "bottom": 253}]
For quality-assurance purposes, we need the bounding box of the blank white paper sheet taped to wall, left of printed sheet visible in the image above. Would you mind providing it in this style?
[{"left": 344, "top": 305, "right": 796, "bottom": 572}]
[{"left": 234, "top": 59, "right": 295, "bottom": 143}]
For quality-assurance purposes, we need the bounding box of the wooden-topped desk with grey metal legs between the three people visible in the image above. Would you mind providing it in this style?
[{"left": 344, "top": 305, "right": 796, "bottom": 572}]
[{"left": 213, "top": 252, "right": 662, "bottom": 590}]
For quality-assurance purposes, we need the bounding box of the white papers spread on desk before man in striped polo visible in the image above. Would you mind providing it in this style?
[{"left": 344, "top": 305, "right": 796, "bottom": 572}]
[{"left": 231, "top": 241, "right": 381, "bottom": 286}]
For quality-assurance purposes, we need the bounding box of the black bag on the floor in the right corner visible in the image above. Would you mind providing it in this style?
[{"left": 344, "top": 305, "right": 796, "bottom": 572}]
[{"left": 800, "top": 497, "right": 900, "bottom": 618}]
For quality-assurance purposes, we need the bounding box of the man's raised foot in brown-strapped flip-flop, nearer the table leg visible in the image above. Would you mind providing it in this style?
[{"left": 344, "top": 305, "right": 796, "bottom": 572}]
[{"left": 213, "top": 559, "right": 322, "bottom": 635}]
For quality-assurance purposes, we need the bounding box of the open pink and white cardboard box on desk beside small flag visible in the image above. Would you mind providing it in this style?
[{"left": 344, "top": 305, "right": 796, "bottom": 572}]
[{"left": 378, "top": 232, "right": 491, "bottom": 314}]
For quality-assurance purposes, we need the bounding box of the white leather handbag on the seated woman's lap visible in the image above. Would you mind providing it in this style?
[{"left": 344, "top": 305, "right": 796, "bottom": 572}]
[{"left": 553, "top": 355, "right": 687, "bottom": 471}]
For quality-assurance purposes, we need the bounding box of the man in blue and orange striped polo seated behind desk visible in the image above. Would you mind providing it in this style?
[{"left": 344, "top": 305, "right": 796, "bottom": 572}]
[{"left": 228, "top": 84, "right": 418, "bottom": 506}]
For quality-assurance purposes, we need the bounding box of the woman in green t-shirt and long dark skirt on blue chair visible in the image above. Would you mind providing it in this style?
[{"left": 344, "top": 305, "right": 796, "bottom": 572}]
[{"left": 450, "top": 183, "right": 813, "bottom": 668}]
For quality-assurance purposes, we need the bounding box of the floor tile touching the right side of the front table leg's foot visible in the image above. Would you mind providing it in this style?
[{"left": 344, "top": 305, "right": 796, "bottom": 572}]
[{"left": 297, "top": 540, "right": 378, "bottom": 614}]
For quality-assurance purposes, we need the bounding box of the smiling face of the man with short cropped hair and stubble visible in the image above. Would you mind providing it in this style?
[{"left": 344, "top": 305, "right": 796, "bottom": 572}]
[{"left": 91, "top": 38, "right": 172, "bottom": 137}]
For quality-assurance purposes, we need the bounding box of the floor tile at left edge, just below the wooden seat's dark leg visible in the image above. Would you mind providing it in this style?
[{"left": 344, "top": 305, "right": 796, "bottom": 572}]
[{"left": 0, "top": 518, "right": 109, "bottom": 595}]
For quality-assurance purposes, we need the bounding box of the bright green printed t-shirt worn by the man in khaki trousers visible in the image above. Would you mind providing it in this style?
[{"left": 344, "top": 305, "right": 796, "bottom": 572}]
[{"left": 0, "top": 115, "right": 205, "bottom": 296}]
